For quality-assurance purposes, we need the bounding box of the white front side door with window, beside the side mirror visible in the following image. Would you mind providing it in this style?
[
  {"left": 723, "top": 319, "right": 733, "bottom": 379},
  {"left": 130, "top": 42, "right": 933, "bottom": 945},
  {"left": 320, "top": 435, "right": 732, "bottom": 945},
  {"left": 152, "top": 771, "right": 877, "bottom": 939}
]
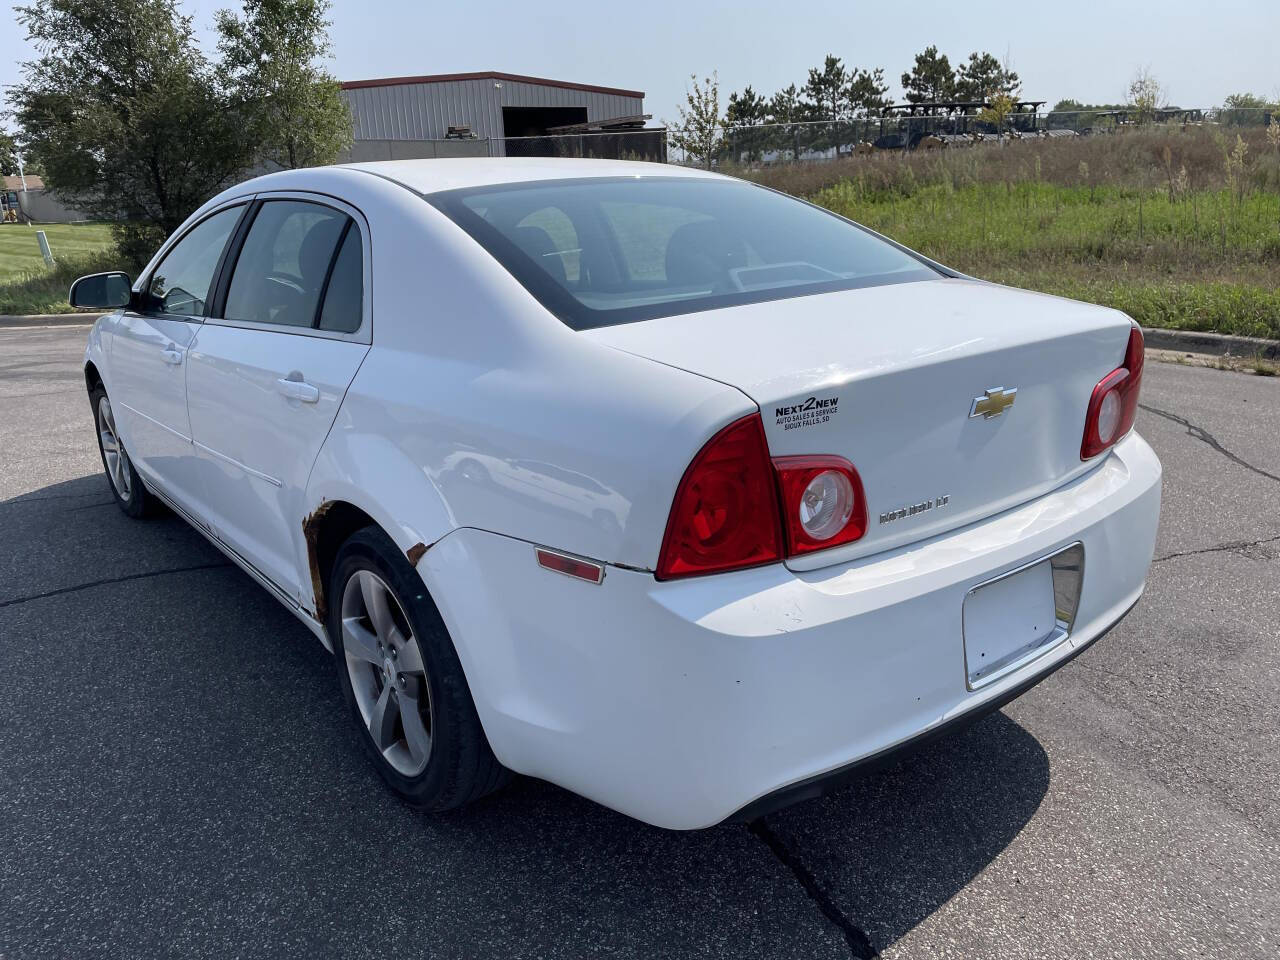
[{"left": 109, "top": 202, "right": 247, "bottom": 508}]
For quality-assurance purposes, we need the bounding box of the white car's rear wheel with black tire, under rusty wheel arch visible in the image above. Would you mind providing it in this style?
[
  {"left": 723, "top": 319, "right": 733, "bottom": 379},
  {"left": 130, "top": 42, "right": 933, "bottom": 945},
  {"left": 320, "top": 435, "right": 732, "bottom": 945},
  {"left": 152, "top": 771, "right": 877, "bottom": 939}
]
[{"left": 326, "top": 527, "right": 512, "bottom": 812}]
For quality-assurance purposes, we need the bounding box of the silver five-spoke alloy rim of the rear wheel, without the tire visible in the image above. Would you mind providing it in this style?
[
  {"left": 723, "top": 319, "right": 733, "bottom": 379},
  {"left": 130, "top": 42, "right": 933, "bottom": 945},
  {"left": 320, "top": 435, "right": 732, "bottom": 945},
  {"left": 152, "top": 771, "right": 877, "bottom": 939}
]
[{"left": 342, "top": 570, "right": 433, "bottom": 777}]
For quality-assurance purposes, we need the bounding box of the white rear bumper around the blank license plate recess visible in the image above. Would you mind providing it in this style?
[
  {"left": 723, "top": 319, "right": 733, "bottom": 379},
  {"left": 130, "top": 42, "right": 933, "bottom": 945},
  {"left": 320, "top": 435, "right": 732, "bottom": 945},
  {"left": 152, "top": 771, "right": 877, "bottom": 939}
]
[{"left": 419, "top": 434, "right": 1161, "bottom": 828}]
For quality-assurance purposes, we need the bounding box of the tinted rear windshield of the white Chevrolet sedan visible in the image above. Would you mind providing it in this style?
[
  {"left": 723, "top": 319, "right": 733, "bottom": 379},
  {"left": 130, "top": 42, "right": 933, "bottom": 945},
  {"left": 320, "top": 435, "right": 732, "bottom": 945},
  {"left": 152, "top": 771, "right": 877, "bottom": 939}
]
[{"left": 428, "top": 177, "right": 940, "bottom": 330}]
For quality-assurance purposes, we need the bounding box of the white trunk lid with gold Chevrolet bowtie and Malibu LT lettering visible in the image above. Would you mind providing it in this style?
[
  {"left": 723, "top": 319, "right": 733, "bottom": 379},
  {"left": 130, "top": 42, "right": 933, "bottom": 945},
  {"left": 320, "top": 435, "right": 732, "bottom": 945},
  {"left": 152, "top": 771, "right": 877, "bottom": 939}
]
[{"left": 584, "top": 279, "right": 1130, "bottom": 570}]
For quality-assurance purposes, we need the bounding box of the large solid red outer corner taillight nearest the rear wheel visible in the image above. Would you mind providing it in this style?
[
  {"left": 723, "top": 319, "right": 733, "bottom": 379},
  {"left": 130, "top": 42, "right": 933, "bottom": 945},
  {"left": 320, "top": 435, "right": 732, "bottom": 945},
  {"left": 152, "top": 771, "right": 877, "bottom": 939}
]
[{"left": 655, "top": 413, "right": 782, "bottom": 580}]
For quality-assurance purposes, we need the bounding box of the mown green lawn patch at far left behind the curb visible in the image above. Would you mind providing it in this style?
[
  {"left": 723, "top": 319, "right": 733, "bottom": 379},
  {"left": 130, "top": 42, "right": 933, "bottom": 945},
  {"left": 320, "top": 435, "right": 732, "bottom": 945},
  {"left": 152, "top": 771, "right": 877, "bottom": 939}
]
[{"left": 0, "top": 224, "right": 119, "bottom": 315}]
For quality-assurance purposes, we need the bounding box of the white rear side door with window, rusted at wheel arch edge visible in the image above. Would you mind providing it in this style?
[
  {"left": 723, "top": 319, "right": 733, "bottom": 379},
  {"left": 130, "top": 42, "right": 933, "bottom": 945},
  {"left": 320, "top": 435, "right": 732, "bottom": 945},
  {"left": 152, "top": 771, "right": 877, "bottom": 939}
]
[{"left": 187, "top": 195, "right": 371, "bottom": 600}]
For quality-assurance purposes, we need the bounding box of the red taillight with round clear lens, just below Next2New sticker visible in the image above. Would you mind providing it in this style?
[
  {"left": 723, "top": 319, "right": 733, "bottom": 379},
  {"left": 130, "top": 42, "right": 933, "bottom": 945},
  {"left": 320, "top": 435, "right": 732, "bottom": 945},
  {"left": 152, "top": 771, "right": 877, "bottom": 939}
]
[{"left": 773, "top": 457, "right": 867, "bottom": 557}]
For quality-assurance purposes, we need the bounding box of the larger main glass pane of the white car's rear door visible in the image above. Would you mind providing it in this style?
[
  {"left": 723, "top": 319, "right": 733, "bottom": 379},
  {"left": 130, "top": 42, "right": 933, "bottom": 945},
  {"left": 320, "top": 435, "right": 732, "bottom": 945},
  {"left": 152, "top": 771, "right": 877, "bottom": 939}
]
[{"left": 223, "top": 200, "right": 348, "bottom": 326}]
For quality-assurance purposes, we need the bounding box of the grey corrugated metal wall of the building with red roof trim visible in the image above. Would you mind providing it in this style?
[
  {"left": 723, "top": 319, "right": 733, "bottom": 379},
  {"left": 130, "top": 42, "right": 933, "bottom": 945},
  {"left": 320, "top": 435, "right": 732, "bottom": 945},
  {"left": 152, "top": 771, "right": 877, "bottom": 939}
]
[{"left": 342, "top": 78, "right": 644, "bottom": 142}]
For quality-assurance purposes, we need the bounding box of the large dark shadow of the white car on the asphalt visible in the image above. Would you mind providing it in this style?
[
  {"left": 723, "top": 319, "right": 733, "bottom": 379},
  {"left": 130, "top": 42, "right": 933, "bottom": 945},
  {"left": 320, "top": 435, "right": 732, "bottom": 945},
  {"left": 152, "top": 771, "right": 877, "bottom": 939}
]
[{"left": 0, "top": 475, "right": 1050, "bottom": 959}]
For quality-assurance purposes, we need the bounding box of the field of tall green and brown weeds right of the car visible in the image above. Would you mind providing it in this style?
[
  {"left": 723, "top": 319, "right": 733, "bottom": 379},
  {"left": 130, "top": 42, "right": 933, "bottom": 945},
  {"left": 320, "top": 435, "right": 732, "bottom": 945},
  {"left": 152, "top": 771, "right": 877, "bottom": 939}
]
[{"left": 739, "top": 125, "right": 1280, "bottom": 337}]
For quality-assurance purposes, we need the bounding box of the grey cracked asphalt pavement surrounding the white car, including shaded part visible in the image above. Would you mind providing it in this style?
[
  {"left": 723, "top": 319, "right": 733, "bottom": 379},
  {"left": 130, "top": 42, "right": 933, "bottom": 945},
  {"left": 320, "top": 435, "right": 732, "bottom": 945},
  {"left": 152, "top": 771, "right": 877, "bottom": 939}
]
[{"left": 0, "top": 326, "right": 1280, "bottom": 960}]
